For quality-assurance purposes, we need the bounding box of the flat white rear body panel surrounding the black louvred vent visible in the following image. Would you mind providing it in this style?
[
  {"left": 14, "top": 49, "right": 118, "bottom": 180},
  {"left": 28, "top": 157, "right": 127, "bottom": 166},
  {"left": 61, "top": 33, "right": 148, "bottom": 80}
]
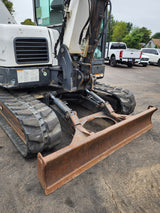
[{"left": 0, "top": 24, "right": 52, "bottom": 67}]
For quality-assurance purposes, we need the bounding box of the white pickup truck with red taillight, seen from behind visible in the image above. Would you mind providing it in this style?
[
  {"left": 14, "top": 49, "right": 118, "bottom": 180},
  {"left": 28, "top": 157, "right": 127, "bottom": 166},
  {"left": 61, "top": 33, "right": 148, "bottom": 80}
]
[{"left": 105, "top": 42, "right": 142, "bottom": 67}]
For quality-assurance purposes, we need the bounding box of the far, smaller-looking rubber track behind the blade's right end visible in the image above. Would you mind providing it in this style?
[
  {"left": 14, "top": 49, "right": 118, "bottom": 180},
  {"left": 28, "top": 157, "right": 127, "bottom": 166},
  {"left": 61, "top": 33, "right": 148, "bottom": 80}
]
[{"left": 94, "top": 82, "right": 136, "bottom": 115}]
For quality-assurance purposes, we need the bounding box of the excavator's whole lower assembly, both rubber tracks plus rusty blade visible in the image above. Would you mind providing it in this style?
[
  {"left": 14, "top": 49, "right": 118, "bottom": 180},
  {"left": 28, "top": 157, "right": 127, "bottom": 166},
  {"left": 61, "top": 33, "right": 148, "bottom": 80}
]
[{"left": 0, "top": 83, "right": 156, "bottom": 194}]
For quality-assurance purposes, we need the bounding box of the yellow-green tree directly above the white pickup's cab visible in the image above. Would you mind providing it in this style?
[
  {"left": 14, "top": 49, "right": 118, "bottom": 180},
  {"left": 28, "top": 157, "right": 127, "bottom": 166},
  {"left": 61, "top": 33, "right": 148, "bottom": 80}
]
[{"left": 112, "top": 21, "right": 128, "bottom": 42}]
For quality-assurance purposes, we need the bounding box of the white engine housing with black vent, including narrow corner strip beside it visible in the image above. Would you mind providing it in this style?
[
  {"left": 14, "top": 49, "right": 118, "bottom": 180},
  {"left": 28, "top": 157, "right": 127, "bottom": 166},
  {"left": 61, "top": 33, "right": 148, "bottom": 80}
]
[{"left": 0, "top": 24, "right": 59, "bottom": 67}]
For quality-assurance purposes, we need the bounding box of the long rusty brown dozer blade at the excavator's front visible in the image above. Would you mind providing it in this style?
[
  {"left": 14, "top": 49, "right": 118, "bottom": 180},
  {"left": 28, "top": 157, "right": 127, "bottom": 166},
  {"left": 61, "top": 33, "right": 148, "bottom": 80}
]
[{"left": 38, "top": 107, "right": 157, "bottom": 195}]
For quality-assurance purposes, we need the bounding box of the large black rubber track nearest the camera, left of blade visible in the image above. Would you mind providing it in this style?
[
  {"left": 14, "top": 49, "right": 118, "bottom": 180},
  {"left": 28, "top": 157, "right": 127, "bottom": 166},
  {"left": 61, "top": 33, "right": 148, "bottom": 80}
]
[{"left": 0, "top": 89, "right": 61, "bottom": 157}]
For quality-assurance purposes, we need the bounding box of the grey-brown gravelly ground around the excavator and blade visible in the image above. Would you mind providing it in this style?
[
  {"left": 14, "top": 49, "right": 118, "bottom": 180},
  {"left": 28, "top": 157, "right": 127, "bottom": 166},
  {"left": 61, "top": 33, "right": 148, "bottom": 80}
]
[{"left": 0, "top": 65, "right": 160, "bottom": 213}]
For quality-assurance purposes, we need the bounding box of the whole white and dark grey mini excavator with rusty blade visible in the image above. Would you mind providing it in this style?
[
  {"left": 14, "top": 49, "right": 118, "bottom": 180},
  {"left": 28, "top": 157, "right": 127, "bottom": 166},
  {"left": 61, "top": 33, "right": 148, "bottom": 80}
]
[{"left": 0, "top": 0, "right": 156, "bottom": 194}]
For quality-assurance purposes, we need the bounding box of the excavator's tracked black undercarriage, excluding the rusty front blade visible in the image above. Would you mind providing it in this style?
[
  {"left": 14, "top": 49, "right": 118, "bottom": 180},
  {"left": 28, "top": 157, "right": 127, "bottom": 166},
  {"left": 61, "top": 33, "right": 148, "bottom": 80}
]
[{"left": 0, "top": 83, "right": 135, "bottom": 157}]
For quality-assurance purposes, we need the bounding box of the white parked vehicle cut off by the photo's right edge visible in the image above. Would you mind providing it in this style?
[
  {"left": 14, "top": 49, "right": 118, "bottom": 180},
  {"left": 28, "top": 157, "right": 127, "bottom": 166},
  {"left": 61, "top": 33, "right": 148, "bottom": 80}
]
[{"left": 142, "top": 48, "right": 160, "bottom": 66}]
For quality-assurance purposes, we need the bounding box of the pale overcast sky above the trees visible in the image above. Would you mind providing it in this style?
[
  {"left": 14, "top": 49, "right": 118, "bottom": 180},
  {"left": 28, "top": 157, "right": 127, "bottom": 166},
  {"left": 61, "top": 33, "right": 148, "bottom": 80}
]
[{"left": 11, "top": 0, "right": 160, "bottom": 34}]
